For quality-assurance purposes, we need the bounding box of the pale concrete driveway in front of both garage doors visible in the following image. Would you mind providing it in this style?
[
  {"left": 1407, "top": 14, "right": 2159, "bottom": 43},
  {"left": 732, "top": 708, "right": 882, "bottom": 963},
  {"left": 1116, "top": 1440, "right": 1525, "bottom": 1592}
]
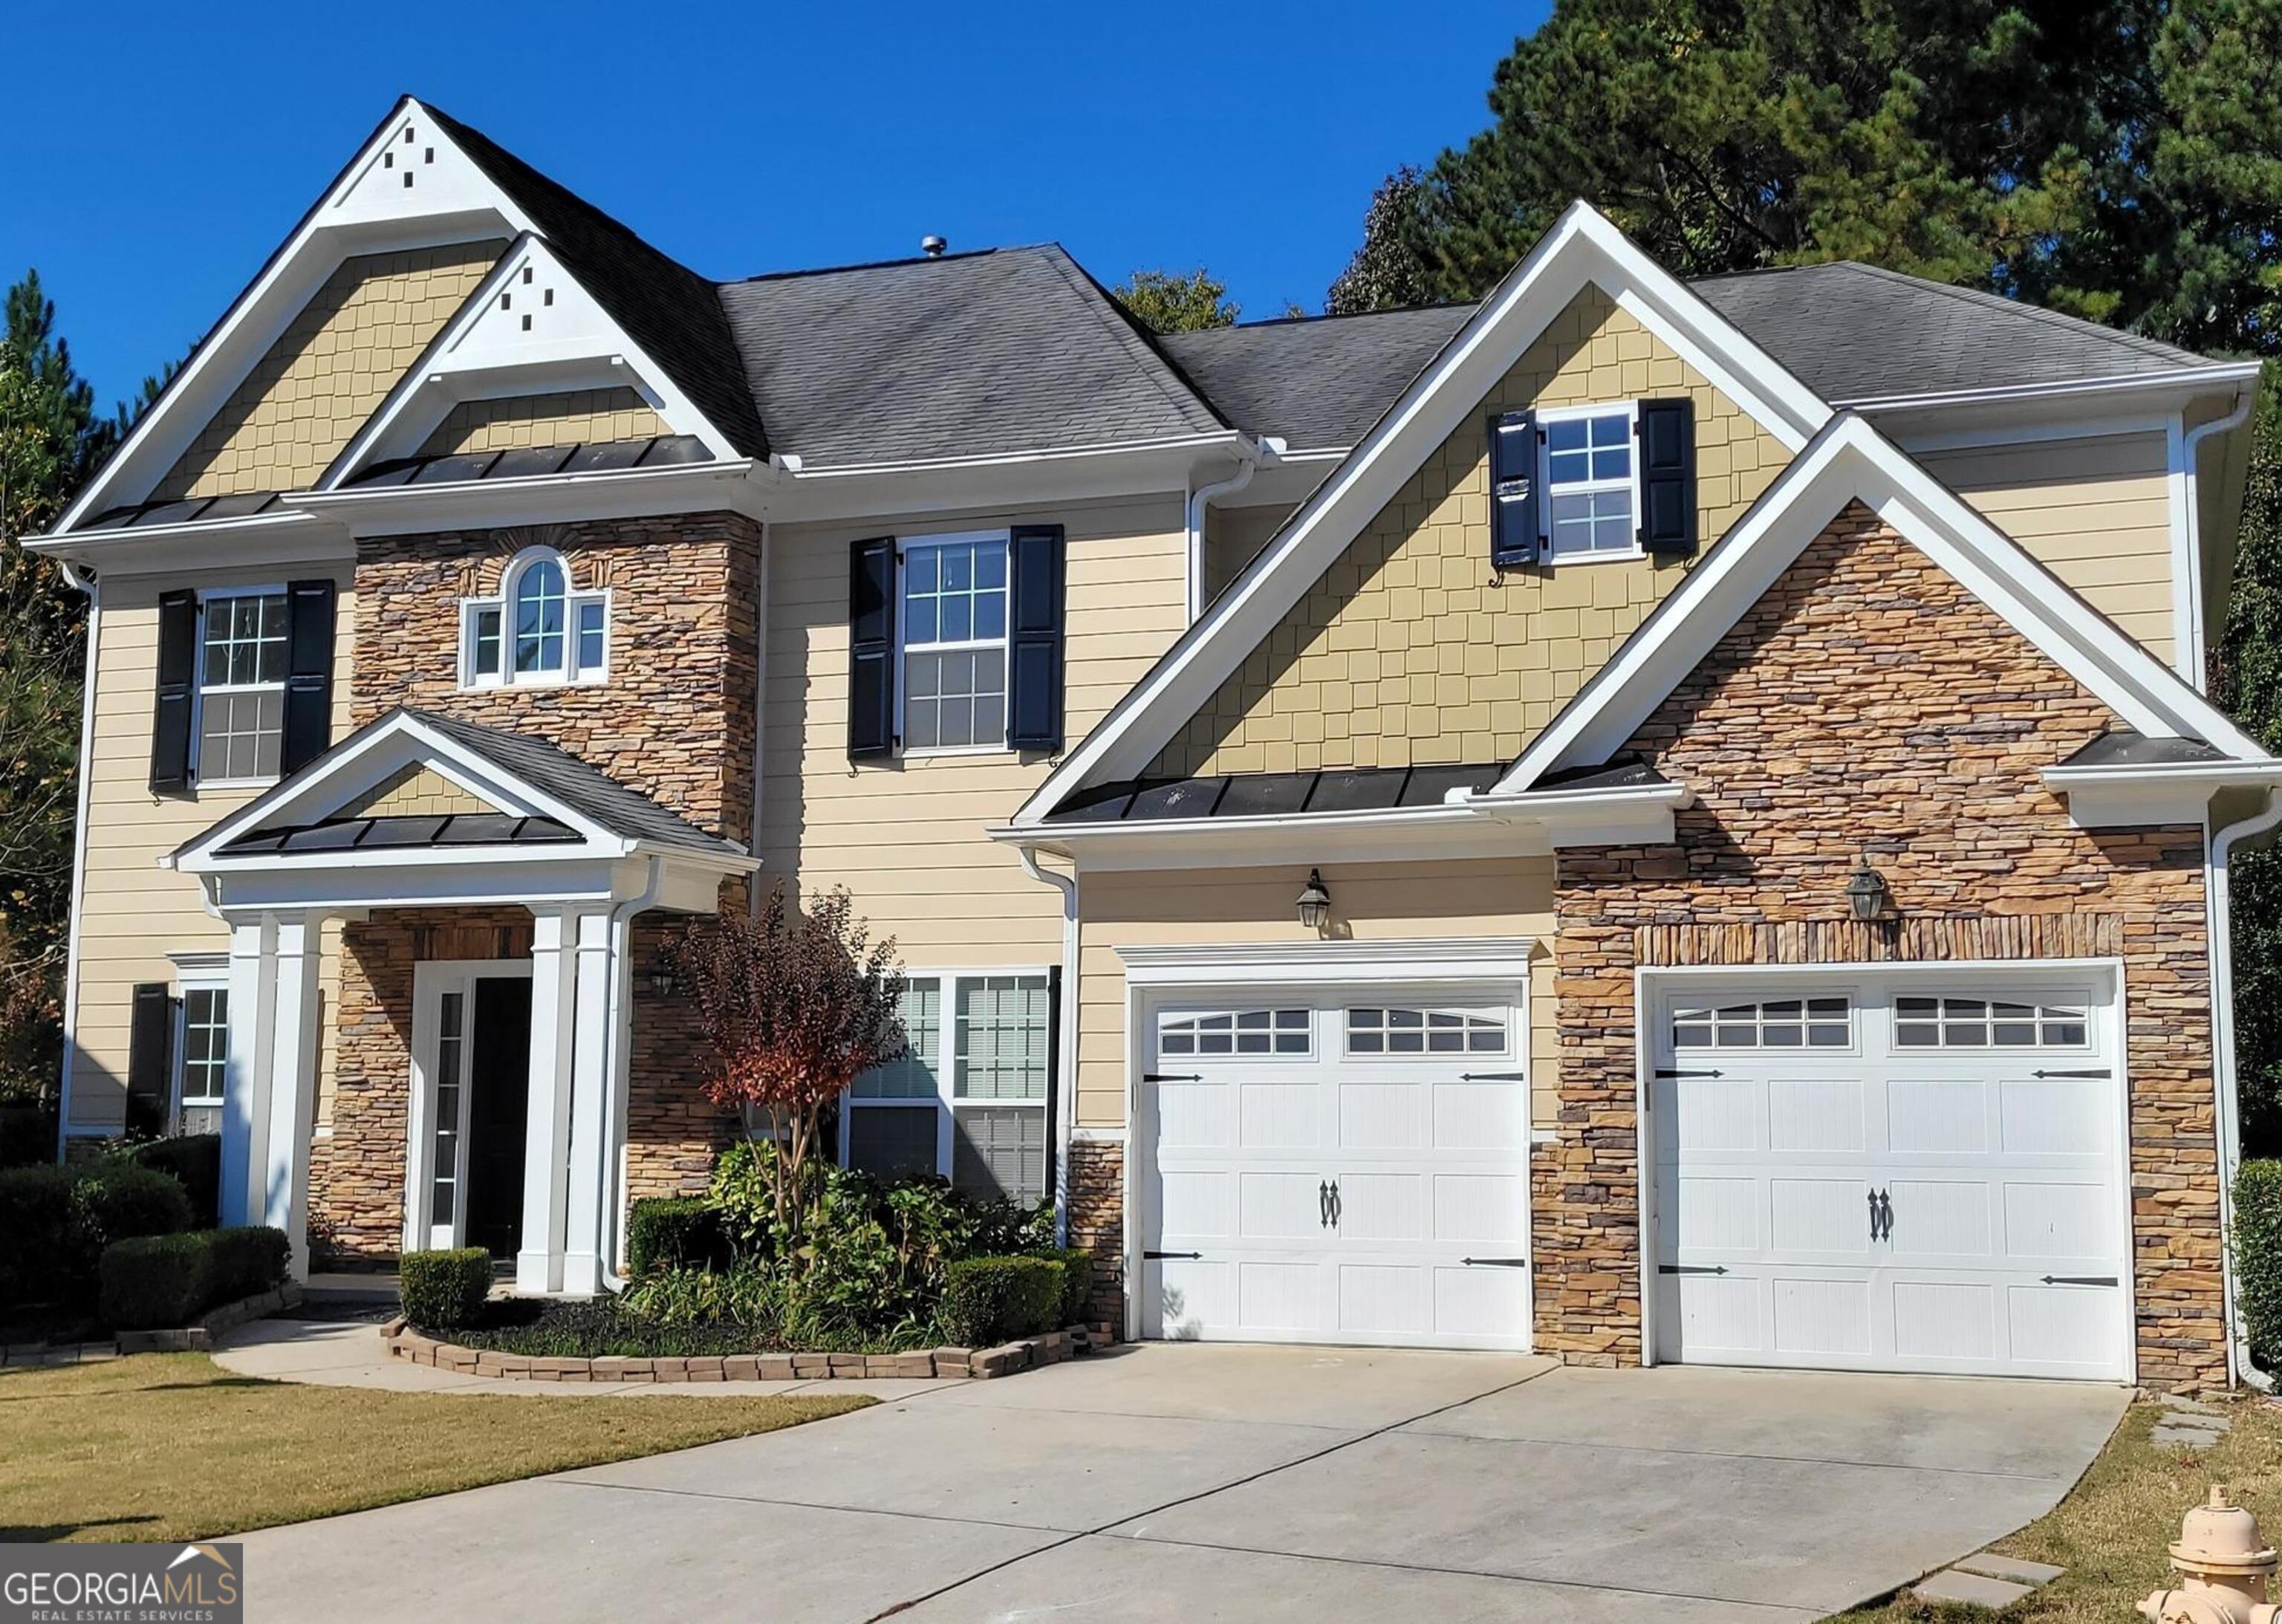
[{"left": 231, "top": 1345, "right": 2127, "bottom": 1624}]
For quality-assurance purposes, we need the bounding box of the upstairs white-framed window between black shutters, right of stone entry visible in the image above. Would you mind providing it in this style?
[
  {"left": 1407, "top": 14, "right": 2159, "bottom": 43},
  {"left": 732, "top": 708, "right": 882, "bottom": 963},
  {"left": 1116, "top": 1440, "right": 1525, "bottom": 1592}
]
[{"left": 897, "top": 531, "right": 1007, "bottom": 753}]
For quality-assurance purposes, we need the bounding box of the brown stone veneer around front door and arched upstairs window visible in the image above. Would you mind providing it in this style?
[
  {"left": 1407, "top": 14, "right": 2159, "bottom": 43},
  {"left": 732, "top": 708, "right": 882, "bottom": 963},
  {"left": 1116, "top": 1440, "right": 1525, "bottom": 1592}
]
[{"left": 311, "top": 513, "right": 760, "bottom": 1259}]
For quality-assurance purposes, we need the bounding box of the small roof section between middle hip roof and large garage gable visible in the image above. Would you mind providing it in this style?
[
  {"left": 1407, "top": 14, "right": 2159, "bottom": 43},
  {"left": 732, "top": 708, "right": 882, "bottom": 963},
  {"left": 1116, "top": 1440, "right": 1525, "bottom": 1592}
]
[{"left": 1164, "top": 305, "right": 1475, "bottom": 452}]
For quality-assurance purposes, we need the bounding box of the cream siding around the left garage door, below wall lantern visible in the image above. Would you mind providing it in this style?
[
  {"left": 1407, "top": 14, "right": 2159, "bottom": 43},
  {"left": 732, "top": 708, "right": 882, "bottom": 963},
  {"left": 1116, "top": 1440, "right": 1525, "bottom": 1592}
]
[{"left": 1077, "top": 857, "right": 1556, "bottom": 1127}]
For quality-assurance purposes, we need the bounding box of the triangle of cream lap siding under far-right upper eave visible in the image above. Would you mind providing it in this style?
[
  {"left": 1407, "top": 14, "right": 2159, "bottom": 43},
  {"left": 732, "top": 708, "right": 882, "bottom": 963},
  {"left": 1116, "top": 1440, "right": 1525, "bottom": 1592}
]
[{"left": 1917, "top": 429, "right": 2177, "bottom": 663}]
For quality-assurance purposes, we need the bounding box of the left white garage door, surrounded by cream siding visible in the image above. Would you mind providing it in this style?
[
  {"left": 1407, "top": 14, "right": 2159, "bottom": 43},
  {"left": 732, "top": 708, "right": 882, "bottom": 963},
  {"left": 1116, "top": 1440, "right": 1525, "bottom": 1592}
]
[{"left": 1134, "top": 990, "right": 1529, "bottom": 1348}]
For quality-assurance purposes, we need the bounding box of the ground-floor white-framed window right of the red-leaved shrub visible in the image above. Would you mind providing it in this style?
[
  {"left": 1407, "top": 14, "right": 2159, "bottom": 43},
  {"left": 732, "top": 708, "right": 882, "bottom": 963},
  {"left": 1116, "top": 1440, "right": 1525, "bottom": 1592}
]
[{"left": 839, "top": 972, "right": 1054, "bottom": 1204}]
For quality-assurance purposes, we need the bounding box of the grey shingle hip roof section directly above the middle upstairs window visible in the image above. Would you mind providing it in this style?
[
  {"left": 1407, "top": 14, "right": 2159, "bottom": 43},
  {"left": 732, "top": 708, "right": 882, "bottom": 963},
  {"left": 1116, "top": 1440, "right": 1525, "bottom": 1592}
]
[{"left": 721, "top": 247, "right": 1226, "bottom": 465}]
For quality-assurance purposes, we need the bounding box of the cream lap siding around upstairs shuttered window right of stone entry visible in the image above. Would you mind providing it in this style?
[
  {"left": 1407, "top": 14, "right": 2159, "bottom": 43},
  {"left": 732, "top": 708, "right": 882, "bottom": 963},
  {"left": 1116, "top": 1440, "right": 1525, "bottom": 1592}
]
[{"left": 760, "top": 495, "right": 1186, "bottom": 969}]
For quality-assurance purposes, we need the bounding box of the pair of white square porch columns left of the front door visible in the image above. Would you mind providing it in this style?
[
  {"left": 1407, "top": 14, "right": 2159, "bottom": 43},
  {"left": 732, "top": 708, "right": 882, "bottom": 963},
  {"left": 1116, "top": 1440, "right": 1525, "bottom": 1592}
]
[{"left": 221, "top": 912, "right": 319, "bottom": 1279}]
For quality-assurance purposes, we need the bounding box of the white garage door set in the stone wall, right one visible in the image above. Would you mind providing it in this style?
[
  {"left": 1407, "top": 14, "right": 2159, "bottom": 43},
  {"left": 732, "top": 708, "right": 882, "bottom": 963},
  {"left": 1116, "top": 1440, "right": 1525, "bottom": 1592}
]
[{"left": 1648, "top": 967, "right": 2131, "bottom": 1380}]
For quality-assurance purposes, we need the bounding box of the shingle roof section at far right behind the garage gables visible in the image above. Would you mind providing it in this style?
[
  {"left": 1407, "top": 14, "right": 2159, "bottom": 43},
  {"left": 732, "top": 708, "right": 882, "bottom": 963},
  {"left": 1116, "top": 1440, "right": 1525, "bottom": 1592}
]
[{"left": 1691, "top": 260, "right": 2209, "bottom": 406}]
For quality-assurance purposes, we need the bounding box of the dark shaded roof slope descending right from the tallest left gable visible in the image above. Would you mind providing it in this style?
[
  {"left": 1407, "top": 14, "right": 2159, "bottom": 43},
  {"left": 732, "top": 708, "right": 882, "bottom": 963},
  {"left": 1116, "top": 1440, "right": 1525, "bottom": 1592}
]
[{"left": 429, "top": 105, "right": 769, "bottom": 456}]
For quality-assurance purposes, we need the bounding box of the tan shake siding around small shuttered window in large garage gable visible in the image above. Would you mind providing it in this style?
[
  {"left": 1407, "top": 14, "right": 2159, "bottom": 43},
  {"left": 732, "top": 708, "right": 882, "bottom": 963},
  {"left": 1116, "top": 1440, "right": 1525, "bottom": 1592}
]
[{"left": 1150, "top": 288, "right": 1789, "bottom": 778}]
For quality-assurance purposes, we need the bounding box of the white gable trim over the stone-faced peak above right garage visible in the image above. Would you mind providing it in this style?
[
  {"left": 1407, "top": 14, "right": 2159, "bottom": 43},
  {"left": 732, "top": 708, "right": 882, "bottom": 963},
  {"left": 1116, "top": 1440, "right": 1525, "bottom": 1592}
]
[{"left": 1488, "top": 415, "right": 2269, "bottom": 796}]
